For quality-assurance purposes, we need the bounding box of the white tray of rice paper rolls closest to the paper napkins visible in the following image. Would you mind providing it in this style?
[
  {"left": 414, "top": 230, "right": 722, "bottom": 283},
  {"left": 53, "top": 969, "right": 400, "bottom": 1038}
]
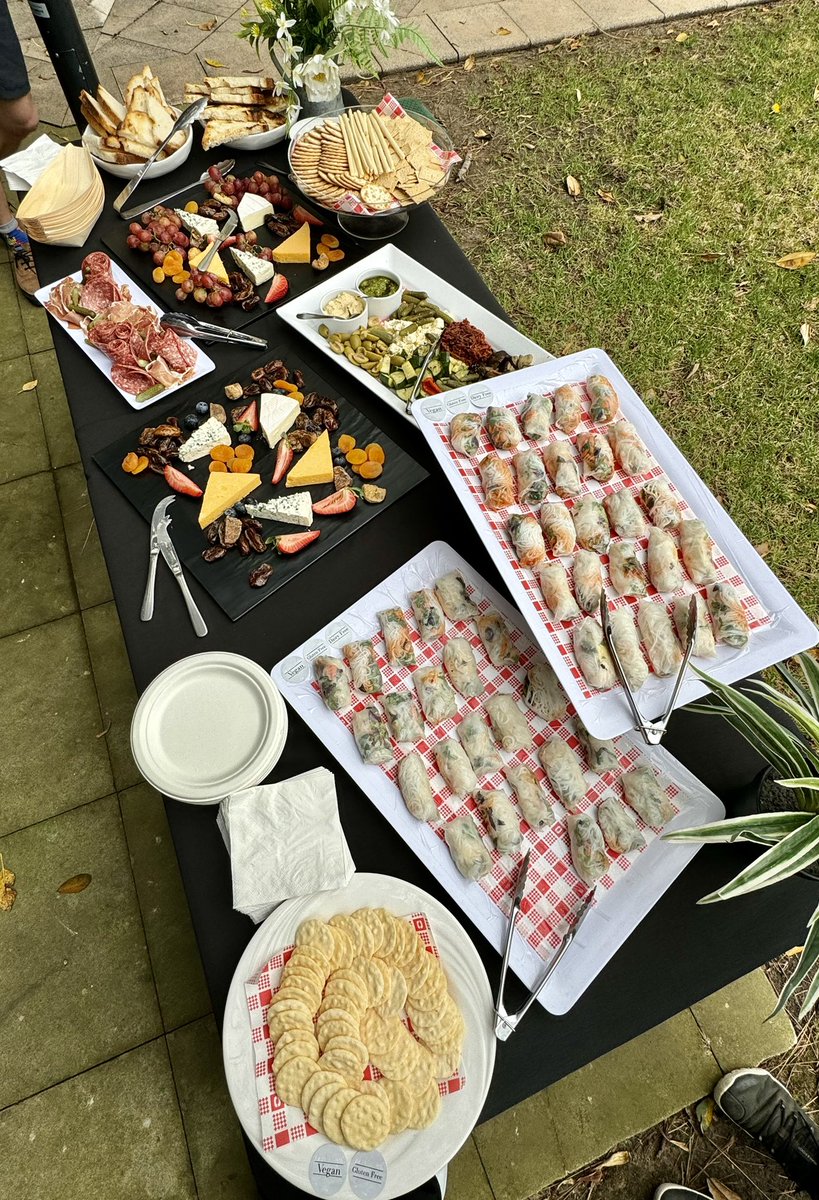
[{"left": 271, "top": 541, "right": 724, "bottom": 1014}]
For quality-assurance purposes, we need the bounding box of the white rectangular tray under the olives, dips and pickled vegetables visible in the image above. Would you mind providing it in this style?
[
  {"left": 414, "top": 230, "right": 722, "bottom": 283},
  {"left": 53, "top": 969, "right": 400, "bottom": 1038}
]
[{"left": 276, "top": 244, "right": 554, "bottom": 421}]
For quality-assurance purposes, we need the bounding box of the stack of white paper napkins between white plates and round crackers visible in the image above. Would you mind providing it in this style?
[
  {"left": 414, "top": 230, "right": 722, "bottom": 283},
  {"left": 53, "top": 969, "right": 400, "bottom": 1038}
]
[{"left": 217, "top": 767, "right": 355, "bottom": 924}]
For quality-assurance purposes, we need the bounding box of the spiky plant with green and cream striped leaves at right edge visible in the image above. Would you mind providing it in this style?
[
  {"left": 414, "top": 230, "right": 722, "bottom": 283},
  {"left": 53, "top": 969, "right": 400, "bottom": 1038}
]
[{"left": 665, "top": 654, "right": 819, "bottom": 1020}]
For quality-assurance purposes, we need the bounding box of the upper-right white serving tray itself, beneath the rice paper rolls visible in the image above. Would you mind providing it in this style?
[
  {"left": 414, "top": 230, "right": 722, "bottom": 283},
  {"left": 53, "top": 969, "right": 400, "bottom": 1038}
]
[{"left": 412, "top": 349, "right": 819, "bottom": 738}]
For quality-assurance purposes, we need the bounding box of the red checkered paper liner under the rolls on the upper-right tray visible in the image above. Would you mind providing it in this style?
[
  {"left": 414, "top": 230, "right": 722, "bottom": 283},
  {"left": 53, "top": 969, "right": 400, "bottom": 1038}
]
[{"left": 431, "top": 384, "right": 770, "bottom": 700}]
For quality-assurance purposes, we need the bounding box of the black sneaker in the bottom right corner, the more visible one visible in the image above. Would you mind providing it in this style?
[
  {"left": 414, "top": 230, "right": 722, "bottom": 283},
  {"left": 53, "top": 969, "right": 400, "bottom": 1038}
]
[{"left": 713, "top": 1068, "right": 819, "bottom": 1195}]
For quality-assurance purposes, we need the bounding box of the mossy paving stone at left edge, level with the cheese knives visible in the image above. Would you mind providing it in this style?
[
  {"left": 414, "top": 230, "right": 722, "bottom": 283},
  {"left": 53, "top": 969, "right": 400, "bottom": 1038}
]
[{"left": 0, "top": 472, "right": 77, "bottom": 637}]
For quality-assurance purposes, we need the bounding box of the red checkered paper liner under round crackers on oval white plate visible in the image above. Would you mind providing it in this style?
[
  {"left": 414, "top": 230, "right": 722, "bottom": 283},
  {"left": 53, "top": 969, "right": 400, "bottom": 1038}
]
[{"left": 245, "top": 912, "right": 466, "bottom": 1151}]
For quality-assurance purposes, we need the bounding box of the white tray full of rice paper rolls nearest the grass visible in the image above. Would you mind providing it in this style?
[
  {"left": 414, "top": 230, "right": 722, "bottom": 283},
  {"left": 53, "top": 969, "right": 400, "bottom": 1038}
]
[{"left": 413, "top": 349, "right": 819, "bottom": 738}]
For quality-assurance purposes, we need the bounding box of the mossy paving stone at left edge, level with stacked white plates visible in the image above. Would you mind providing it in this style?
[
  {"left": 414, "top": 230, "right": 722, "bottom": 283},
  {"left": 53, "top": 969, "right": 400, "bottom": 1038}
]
[{"left": 0, "top": 614, "right": 114, "bottom": 835}]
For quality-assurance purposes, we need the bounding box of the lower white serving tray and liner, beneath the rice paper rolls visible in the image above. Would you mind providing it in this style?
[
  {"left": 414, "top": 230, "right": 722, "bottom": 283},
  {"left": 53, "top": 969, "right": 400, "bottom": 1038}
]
[{"left": 271, "top": 541, "right": 725, "bottom": 1014}]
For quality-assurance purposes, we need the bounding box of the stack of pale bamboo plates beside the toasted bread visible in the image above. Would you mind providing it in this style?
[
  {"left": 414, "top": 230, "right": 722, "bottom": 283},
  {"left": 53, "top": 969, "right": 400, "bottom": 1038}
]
[{"left": 17, "top": 145, "right": 106, "bottom": 246}]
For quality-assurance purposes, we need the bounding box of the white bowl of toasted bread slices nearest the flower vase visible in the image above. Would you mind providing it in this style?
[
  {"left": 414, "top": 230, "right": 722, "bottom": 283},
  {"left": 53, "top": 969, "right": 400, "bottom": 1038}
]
[{"left": 185, "top": 76, "right": 299, "bottom": 150}]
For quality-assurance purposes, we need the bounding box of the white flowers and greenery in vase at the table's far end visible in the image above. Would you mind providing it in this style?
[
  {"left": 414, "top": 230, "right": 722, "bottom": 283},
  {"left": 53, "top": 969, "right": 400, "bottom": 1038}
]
[{"left": 238, "top": 0, "right": 438, "bottom": 116}]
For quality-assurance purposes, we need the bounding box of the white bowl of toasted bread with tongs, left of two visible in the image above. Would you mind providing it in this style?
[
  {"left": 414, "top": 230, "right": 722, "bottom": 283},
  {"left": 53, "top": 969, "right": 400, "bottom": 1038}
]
[{"left": 79, "top": 66, "right": 193, "bottom": 179}]
